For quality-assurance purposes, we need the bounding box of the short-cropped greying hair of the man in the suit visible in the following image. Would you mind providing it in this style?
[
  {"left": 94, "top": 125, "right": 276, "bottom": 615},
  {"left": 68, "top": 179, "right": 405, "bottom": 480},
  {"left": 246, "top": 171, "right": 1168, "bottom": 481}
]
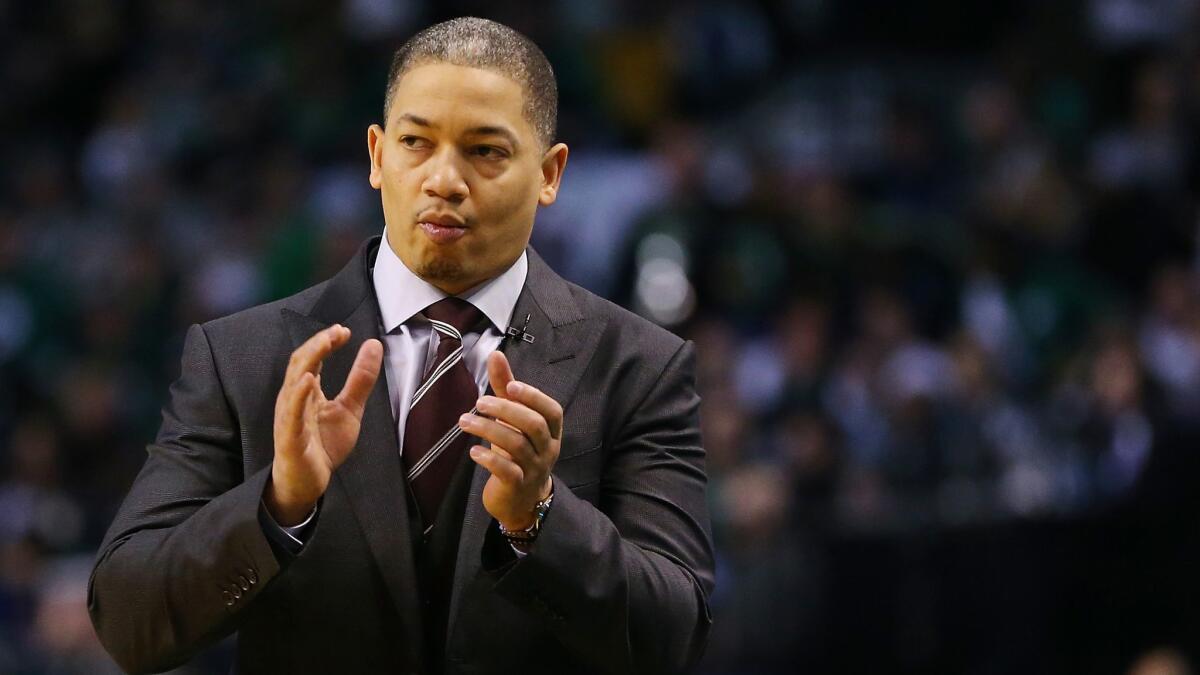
[{"left": 383, "top": 17, "right": 558, "bottom": 148}]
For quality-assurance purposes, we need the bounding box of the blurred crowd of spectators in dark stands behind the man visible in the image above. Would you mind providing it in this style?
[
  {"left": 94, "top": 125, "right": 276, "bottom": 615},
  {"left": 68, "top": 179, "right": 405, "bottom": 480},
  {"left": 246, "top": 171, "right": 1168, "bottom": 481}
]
[{"left": 0, "top": 0, "right": 1200, "bottom": 675}]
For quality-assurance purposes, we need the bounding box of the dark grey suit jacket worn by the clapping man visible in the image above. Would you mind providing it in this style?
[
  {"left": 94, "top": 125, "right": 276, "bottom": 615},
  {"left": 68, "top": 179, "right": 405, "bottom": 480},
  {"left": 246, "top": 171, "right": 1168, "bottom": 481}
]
[{"left": 88, "top": 237, "right": 713, "bottom": 674}]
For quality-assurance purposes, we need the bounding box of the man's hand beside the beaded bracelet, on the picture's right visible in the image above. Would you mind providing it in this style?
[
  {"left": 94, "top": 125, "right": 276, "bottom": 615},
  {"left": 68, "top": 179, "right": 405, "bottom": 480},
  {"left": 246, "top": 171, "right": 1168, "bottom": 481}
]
[{"left": 458, "top": 352, "right": 563, "bottom": 531}]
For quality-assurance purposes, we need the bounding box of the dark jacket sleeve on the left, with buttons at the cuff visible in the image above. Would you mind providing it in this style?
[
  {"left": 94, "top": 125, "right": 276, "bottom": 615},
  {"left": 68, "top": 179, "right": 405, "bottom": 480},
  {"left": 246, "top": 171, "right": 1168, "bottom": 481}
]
[{"left": 88, "top": 325, "right": 283, "bottom": 673}]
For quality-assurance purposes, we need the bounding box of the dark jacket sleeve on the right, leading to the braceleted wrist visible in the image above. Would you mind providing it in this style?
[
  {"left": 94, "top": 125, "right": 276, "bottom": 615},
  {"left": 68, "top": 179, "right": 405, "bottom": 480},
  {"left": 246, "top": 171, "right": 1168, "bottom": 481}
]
[{"left": 484, "top": 342, "right": 714, "bottom": 674}]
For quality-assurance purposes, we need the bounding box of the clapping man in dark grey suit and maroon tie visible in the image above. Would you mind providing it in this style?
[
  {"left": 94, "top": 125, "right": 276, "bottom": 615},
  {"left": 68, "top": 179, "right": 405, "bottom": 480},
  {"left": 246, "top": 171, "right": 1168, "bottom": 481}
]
[{"left": 89, "top": 18, "right": 713, "bottom": 673}]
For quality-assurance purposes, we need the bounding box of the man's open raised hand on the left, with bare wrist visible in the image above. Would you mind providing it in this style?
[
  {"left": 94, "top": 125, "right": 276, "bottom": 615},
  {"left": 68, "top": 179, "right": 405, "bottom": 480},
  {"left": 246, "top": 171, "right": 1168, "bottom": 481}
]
[{"left": 263, "top": 324, "right": 383, "bottom": 526}]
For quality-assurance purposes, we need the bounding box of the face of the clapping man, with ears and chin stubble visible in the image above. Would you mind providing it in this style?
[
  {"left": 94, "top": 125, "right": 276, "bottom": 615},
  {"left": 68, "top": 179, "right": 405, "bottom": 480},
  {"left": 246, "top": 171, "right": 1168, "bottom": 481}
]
[{"left": 367, "top": 62, "right": 566, "bottom": 294}]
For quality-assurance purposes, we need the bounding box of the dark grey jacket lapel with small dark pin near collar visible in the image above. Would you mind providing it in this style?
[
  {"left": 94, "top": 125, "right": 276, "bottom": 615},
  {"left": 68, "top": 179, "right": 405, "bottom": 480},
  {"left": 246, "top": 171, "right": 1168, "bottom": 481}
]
[{"left": 446, "top": 249, "right": 602, "bottom": 645}]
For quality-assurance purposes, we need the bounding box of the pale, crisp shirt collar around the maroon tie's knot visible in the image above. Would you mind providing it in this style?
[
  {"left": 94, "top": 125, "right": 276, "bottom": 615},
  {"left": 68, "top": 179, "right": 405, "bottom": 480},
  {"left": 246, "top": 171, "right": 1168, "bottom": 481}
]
[{"left": 372, "top": 228, "right": 529, "bottom": 334}]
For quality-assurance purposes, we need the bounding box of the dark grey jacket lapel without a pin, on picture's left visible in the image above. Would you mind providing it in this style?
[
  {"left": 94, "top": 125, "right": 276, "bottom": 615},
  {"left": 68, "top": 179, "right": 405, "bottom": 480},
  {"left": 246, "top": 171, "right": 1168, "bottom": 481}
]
[{"left": 283, "top": 237, "right": 422, "bottom": 645}]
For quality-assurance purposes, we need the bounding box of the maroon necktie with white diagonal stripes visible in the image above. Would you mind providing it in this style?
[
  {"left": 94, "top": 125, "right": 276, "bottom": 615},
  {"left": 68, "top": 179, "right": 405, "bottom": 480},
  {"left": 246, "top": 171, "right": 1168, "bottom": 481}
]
[{"left": 402, "top": 297, "right": 486, "bottom": 532}]
